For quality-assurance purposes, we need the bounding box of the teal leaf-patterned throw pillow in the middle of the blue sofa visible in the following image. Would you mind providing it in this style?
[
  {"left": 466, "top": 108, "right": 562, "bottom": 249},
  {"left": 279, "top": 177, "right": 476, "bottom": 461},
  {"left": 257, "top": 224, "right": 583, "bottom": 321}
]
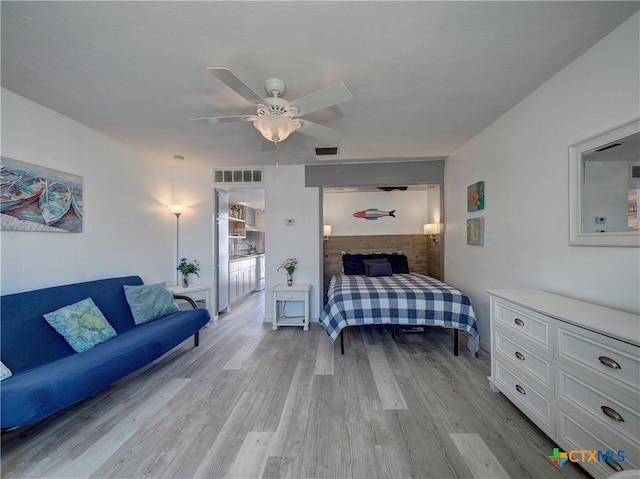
[{"left": 44, "top": 298, "right": 116, "bottom": 353}]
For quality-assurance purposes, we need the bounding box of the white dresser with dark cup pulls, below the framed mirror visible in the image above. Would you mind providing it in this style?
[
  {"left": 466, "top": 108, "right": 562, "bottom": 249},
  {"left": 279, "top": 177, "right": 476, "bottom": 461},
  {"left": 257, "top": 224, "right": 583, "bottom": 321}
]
[{"left": 488, "top": 289, "right": 640, "bottom": 478}]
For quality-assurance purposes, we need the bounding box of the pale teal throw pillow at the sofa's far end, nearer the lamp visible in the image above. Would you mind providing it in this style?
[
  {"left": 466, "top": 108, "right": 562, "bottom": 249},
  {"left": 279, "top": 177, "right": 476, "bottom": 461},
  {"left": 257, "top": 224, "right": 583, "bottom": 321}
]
[{"left": 123, "top": 283, "right": 180, "bottom": 324}]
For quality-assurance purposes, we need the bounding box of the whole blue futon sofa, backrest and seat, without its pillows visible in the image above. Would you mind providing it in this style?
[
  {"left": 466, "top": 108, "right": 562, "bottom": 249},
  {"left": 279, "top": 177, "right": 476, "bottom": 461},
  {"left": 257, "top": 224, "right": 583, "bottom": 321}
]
[{"left": 0, "top": 276, "right": 210, "bottom": 430}]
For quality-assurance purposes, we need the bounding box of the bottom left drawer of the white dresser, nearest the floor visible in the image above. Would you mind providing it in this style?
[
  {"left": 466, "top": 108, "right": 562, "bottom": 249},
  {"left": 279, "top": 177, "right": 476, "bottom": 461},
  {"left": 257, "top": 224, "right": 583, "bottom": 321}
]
[{"left": 493, "top": 358, "right": 555, "bottom": 436}]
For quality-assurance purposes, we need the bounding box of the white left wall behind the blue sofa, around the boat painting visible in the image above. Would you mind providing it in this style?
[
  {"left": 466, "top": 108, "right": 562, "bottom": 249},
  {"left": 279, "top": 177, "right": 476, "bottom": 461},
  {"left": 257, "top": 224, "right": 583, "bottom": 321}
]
[{"left": 0, "top": 89, "right": 175, "bottom": 294}]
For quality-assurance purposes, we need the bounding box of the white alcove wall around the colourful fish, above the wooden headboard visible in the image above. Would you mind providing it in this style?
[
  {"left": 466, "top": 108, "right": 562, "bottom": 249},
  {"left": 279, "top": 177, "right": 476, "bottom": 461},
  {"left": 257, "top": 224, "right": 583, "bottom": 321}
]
[{"left": 323, "top": 190, "right": 428, "bottom": 236}]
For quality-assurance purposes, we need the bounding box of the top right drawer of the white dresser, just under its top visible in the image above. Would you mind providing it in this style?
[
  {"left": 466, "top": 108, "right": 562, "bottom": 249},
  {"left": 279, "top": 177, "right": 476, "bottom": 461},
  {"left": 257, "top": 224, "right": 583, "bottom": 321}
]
[{"left": 555, "top": 321, "right": 640, "bottom": 398}]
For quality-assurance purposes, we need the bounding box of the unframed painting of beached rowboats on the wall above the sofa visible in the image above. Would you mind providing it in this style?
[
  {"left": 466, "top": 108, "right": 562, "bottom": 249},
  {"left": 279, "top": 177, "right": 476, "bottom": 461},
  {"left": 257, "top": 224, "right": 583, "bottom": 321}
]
[{"left": 0, "top": 156, "right": 82, "bottom": 233}]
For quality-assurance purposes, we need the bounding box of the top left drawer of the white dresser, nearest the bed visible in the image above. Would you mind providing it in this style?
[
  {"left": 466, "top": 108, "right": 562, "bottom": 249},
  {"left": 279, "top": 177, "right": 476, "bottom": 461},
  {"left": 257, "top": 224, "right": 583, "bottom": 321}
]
[{"left": 493, "top": 299, "right": 553, "bottom": 356}]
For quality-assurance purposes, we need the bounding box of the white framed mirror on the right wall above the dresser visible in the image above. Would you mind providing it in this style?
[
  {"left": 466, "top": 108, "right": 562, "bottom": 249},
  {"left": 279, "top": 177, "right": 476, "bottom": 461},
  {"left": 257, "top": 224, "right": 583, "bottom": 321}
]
[{"left": 569, "top": 118, "right": 640, "bottom": 247}]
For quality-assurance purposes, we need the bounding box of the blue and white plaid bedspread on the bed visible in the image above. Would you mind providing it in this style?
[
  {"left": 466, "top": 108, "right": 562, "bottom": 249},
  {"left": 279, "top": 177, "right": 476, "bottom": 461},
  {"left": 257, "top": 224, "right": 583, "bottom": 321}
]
[{"left": 320, "top": 273, "right": 480, "bottom": 356}]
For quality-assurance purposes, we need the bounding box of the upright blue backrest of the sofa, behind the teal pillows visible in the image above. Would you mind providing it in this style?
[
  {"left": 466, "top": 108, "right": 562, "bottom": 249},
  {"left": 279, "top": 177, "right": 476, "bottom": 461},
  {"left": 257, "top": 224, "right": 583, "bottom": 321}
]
[{"left": 0, "top": 276, "right": 142, "bottom": 374}]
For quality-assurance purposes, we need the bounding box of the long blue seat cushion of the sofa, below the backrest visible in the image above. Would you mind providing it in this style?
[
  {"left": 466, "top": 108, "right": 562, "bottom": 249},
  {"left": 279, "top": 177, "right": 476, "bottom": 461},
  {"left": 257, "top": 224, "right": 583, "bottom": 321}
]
[{"left": 0, "top": 309, "right": 209, "bottom": 428}]
